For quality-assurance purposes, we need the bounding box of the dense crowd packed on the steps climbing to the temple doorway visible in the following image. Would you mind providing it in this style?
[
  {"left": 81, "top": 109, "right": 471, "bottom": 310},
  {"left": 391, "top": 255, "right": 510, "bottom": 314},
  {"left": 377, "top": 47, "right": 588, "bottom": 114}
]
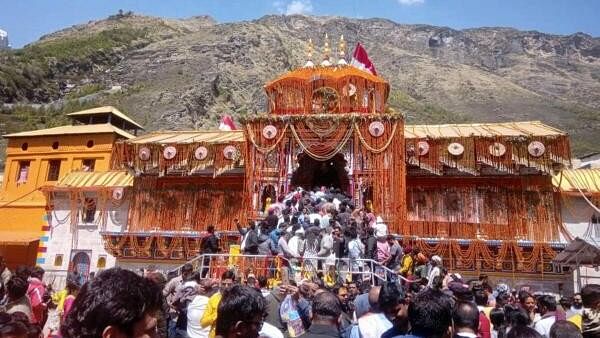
[{"left": 230, "top": 187, "right": 432, "bottom": 284}]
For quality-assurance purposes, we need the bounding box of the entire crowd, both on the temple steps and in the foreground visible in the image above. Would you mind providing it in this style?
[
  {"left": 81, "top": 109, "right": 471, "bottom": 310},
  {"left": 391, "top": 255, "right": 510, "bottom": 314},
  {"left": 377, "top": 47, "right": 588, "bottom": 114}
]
[{"left": 0, "top": 189, "right": 600, "bottom": 338}]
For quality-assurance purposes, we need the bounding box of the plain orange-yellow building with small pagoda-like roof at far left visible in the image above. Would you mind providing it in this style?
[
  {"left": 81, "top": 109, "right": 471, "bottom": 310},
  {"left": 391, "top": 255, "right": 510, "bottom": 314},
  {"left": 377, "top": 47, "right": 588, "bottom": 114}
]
[{"left": 0, "top": 107, "right": 142, "bottom": 267}]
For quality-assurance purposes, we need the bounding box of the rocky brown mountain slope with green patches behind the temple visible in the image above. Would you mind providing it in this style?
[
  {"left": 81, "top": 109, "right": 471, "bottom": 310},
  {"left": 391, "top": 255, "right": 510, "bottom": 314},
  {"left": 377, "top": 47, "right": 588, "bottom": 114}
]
[{"left": 0, "top": 13, "right": 600, "bottom": 158}]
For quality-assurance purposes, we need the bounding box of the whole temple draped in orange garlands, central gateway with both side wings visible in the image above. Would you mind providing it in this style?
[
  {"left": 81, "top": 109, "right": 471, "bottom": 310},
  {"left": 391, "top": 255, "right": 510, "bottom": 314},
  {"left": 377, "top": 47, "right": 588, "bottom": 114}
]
[{"left": 0, "top": 40, "right": 571, "bottom": 288}]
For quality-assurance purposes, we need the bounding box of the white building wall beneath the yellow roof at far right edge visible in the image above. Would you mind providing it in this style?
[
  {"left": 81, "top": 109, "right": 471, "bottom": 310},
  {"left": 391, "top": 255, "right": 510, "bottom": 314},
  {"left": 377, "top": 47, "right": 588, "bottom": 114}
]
[{"left": 561, "top": 195, "right": 600, "bottom": 291}]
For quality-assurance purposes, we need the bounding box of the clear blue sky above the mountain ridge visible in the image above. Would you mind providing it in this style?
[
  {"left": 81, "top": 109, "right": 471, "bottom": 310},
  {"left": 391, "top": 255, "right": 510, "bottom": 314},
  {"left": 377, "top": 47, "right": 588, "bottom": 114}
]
[{"left": 0, "top": 0, "right": 600, "bottom": 47}]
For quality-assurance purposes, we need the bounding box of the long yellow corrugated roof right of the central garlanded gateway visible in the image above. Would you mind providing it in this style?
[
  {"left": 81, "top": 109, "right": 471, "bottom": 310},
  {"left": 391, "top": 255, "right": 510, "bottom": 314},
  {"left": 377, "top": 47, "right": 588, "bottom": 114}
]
[{"left": 404, "top": 121, "right": 567, "bottom": 139}]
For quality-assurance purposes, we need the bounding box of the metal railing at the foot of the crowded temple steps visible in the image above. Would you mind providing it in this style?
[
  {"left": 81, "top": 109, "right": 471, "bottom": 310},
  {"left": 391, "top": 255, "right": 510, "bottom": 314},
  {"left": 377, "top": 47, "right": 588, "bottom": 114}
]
[{"left": 169, "top": 254, "right": 408, "bottom": 285}]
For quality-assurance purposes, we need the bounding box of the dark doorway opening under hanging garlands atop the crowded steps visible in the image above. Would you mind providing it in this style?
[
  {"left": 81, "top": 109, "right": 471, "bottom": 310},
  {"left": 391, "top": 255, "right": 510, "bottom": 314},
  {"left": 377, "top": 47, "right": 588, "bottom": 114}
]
[{"left": 291, "top": 153, "right": 350, "bottom": 193}]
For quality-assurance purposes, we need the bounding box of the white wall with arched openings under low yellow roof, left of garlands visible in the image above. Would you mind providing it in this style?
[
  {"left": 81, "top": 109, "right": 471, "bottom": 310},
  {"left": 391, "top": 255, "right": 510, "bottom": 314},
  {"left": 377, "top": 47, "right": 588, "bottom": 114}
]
[{"left": 41, "top": 192, "right": 129, "bottom": 290}]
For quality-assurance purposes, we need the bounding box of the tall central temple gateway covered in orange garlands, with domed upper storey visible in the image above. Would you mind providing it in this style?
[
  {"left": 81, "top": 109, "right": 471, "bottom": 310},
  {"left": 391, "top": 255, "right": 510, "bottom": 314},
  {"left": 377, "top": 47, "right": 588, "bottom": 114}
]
[{"left": 241, "top": 65, "right": 406, "bottom": 232}]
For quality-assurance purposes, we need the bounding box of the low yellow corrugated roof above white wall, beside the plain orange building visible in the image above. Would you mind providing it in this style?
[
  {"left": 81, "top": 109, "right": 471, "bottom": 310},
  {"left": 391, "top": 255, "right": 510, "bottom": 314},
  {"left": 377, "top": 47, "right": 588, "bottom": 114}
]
[{"left": 50, "top": 171, "right": 133, "bottom": 190}]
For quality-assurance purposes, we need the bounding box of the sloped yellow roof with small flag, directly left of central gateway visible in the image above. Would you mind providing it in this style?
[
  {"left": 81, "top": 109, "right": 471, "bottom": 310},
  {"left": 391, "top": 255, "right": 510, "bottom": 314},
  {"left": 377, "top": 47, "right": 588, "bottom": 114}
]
[{"left": 127, "top": 130, "right": 245, "bottom": 144}]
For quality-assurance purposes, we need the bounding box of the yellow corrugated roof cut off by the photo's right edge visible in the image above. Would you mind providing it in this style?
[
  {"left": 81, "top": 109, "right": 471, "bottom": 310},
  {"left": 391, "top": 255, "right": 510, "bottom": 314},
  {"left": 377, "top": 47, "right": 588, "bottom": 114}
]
[{"left": 552, "top": 168, "right": 600, "bottom": 194}]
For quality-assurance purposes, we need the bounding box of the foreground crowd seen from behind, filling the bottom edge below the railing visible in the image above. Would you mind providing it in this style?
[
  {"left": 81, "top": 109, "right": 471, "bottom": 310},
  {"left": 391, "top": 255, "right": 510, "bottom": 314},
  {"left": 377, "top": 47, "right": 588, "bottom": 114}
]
[{"left": 0, "top": 256, "right": 600, "bottom": 338}]
